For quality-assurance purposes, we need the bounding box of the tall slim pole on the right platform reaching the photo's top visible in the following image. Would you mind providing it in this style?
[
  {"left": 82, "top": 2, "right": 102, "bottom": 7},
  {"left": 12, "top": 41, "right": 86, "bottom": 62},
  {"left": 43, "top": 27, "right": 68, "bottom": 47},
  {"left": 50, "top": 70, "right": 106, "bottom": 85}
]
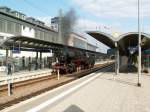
[{"left": 137, "top": 0, "right": 141, "bottom": 87}]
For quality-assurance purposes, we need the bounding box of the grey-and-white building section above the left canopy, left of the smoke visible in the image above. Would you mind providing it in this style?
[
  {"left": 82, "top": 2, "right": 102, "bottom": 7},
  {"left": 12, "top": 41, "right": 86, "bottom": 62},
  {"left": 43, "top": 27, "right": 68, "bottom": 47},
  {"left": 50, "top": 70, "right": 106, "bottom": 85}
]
[{"left": 0, "top": 7, "right": 58, "bottom": 43}]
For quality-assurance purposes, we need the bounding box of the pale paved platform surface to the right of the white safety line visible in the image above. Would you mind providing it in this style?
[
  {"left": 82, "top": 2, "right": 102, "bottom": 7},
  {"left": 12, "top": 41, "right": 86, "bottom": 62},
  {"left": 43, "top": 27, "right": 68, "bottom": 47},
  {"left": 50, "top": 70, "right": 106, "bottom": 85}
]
[{"left": 42, "top": 73, "right": 150, "bottom": 112}]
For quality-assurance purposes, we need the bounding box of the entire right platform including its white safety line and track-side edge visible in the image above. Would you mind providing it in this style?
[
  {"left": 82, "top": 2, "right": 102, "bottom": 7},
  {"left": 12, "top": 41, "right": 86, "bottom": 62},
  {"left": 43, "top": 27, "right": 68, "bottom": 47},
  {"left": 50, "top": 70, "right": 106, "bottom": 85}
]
[{"left": 2, "top": 65, "right": 150, "bottom": 112}]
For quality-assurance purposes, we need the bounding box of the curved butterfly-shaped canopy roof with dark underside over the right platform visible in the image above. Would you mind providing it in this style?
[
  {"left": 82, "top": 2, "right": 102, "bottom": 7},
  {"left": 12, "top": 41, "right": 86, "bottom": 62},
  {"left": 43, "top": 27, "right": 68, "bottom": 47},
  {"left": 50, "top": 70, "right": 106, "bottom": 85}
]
[{"left": 87, "top": 31, "right": 150, "bottom": 55}]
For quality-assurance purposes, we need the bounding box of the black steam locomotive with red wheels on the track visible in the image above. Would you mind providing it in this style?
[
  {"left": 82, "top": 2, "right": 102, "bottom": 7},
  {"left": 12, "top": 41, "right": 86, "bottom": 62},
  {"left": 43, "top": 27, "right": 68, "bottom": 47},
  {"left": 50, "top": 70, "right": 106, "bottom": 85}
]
[{"left": 53, "top": 48, "right": 95, "bottom": 74}]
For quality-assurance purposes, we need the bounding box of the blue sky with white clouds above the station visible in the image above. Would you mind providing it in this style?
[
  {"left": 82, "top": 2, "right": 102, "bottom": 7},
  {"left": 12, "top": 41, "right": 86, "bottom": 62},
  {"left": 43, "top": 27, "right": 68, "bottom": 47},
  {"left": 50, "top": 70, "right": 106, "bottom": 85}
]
[{"left": 0, "top": 0, "right": 150, "bottom": 50}]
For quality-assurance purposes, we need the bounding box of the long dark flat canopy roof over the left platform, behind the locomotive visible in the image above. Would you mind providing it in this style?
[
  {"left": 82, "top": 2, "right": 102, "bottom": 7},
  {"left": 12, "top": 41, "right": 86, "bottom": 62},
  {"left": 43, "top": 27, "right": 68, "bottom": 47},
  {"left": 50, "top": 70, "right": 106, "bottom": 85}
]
[{"left": 0, "top": 36, "right": 106, "bottom": 55}]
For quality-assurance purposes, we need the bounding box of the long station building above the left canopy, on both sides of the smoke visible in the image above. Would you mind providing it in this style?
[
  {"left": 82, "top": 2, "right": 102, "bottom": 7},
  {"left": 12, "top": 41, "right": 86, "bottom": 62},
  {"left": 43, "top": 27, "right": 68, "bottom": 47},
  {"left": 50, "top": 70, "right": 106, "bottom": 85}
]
[{"left": 0, "top": 7, "right": 96, "bottom": 51}]
